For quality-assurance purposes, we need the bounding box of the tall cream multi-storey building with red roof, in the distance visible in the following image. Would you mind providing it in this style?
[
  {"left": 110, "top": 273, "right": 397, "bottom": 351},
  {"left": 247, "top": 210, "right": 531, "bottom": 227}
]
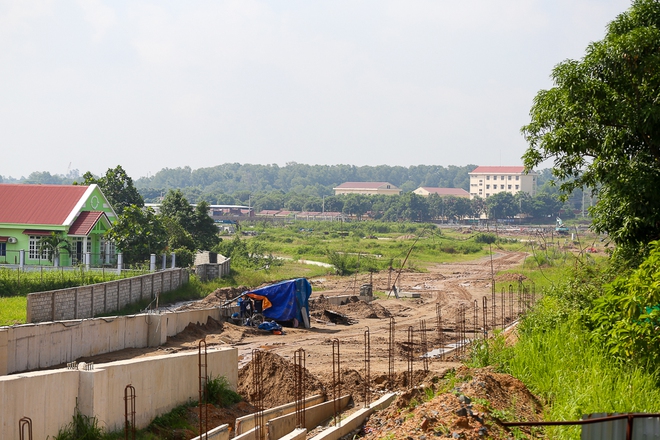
[{"left": 469, "top": 166, "right": 538, "bottom": 199}]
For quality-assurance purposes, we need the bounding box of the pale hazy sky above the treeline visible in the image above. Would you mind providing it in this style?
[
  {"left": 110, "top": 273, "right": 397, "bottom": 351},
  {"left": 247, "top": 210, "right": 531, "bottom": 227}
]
[{"left": 0, "top": 0, "right": 630, "bottom": 179}]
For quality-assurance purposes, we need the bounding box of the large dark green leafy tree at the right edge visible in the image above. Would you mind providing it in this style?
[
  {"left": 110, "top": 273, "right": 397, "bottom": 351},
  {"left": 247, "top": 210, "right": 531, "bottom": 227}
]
[{"left": 522, "top": 0, "right": 660, "bottom": 258}]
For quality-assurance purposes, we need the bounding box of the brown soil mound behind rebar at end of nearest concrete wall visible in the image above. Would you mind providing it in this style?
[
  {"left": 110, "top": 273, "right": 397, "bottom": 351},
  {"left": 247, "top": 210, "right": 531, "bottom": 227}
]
[{"left": 237, "top": 351, "right": 326, "bottom": 408}]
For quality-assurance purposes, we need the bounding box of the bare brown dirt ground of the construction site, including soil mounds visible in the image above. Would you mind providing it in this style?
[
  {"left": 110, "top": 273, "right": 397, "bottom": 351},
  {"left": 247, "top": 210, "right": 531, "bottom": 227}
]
[{"left": 76, "top": 251, "right": 552, "bottom": 439}]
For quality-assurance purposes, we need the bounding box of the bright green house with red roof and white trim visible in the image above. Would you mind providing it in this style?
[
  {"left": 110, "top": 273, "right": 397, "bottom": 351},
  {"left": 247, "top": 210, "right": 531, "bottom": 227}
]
[{"left": 0, "top": 184, "right": 117, "bottom": 266}]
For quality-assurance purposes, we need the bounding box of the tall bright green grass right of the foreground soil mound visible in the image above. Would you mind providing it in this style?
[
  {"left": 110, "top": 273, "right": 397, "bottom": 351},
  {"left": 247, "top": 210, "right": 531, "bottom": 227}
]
[{"left": 506, "top": 321, "right": 660, "bottom": 439}]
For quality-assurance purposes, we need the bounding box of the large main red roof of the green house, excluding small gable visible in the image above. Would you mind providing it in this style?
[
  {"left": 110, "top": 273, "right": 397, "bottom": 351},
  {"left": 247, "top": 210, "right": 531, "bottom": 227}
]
[{"left": 0, "top": 183, "right": 89, "bottom": 225}]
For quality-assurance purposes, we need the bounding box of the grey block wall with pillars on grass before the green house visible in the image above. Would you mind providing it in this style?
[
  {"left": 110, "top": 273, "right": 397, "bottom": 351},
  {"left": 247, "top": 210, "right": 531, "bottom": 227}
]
[{"left": 27, "top": 268, "right": 188, "bottom": 323}]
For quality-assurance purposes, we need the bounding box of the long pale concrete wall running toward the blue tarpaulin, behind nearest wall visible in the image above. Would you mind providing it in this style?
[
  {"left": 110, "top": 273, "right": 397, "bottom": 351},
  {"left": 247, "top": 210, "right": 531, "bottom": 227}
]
[{"left": 0, "top": 308, "right": 220, "bottom": 376}]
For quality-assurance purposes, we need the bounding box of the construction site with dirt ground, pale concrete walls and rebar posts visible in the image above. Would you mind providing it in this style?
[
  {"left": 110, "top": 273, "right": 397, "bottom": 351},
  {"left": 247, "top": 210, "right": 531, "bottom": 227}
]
[{"left": 0, "top": 251, "right": 542, "bottom": 439}]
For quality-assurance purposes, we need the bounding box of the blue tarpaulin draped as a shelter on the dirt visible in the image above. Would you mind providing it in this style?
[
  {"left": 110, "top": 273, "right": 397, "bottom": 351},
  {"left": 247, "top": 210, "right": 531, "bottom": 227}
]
[{"left": 248, "top": 278, "right": 312, "bottom": 325}]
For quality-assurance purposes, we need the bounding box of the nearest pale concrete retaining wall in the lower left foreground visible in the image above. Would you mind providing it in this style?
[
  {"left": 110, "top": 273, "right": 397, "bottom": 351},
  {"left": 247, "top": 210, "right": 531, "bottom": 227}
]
[{"left": 0, "top": 348, "right": 238, "bottom": 439}]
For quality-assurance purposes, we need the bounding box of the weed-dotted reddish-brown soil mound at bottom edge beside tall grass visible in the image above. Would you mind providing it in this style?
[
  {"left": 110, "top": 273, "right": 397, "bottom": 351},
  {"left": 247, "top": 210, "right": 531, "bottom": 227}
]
[{"left": 360, "top": 367, "right": 542, "bottom": 440}]
